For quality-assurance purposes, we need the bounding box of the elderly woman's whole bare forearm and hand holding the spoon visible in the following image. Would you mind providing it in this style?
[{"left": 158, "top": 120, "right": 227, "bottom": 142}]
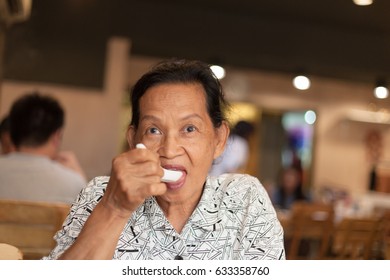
[{"left": 60, "top": 149, "right": 167, "bottom": 260}]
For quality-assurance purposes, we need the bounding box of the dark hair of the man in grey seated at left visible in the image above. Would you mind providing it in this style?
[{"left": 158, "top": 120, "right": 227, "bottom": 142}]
[{"left": 9, "top": 92, "right": 65, "bottom": 147}]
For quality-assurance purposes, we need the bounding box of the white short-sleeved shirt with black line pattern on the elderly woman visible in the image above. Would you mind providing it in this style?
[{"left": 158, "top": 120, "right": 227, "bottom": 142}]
[{"left": 45, "top": 174, "right": 285, "bottom": 260}]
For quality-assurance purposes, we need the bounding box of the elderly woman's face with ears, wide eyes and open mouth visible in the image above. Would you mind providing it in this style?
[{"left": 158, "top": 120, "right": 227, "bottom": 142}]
[{"left": 129, "top": 83, "right": 229, "bottom": 203}]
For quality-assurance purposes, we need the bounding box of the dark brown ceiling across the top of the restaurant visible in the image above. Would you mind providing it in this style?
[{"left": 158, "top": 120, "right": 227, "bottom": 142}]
[{"left": 4, "top": 0, "right": 390, "bottom": 87}]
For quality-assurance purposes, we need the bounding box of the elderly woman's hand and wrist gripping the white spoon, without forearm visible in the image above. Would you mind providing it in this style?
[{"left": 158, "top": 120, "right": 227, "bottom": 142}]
[{"left": 101, "top": 149, "right": 167, "bottom": 217}]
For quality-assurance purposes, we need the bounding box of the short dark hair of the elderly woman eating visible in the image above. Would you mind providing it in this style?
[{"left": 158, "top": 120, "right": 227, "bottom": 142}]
[{"left": 130, "top": 59, "right": 229, "bottom": 128}]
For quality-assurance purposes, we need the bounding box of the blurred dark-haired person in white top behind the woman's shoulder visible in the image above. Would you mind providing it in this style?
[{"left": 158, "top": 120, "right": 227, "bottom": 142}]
[{"left": 209, "top": 120, "right": 255, "bottom": 176}]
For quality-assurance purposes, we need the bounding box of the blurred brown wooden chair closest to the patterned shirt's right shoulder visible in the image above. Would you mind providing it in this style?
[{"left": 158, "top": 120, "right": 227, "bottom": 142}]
[{"left": 286, "top": 202, "right": 334, "bottom": 260}]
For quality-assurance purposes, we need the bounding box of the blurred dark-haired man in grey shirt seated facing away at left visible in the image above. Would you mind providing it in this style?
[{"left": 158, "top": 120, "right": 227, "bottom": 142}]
[{"left": 0, "top": 93, "right": 86, "bottom": 203}]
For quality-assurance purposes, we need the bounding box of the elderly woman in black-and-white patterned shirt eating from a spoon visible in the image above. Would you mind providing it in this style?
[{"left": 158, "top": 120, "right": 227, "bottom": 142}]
[{"left": 47, "top": 60, "right": 285, "bottom": 260}]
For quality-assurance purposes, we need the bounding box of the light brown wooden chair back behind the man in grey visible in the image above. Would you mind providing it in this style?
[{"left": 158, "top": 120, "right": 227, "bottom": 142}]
[{"left": 0, "top": 200, "right": 70, "bottom": 259}]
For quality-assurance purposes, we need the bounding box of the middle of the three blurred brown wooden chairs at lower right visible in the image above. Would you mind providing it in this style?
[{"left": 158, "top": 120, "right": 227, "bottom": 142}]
[{"left": 332, "top": 217, "right": 381, "bottom": 260}]
